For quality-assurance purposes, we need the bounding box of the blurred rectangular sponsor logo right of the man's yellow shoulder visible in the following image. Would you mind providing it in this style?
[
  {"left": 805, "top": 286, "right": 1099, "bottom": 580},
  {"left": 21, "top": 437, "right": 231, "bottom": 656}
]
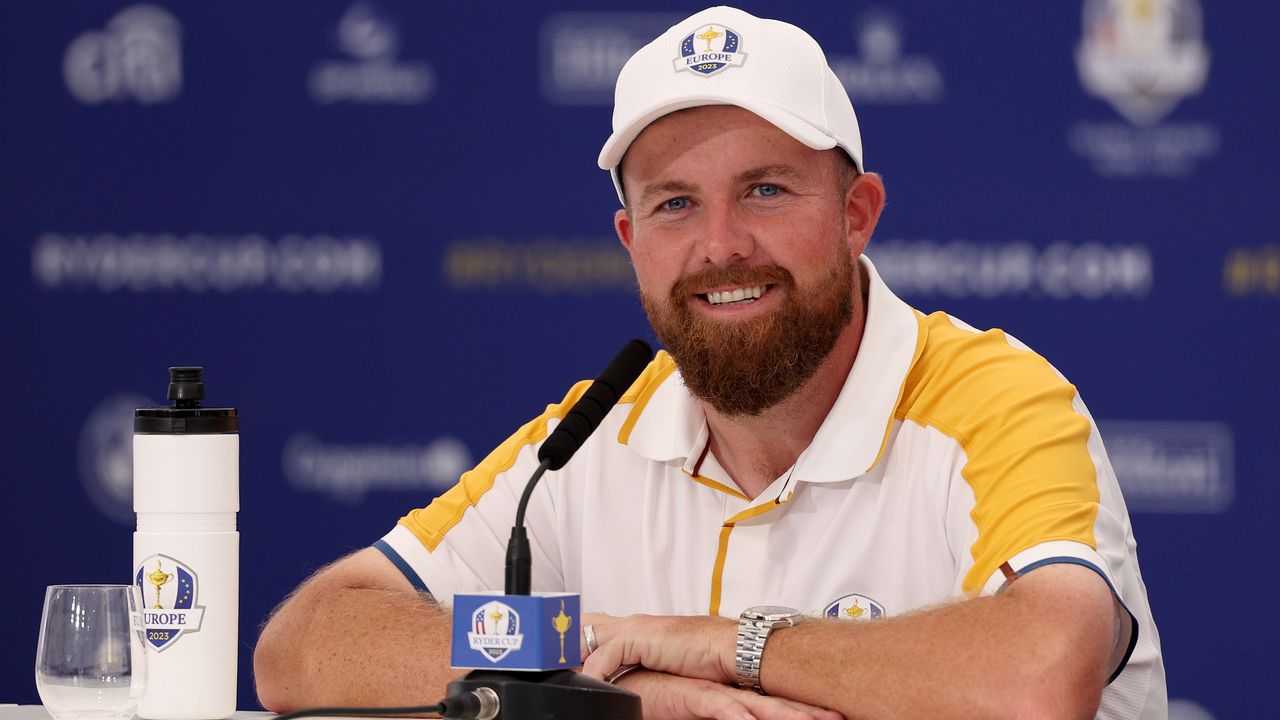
[{"left": 1098, "top": 420, "right": 1235, "bottom": 512}]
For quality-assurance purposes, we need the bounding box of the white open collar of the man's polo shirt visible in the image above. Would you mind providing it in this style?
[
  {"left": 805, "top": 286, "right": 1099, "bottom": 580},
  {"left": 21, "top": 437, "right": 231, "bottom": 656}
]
[{"left": 620, "top": 255, "right": 920, "bottom": 483}]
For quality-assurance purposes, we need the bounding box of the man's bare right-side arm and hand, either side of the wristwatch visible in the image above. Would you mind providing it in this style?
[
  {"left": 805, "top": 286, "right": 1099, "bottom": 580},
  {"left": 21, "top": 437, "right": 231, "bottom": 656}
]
[{"left": 582, "top": 565, "right": 1130, "bottom": 720}]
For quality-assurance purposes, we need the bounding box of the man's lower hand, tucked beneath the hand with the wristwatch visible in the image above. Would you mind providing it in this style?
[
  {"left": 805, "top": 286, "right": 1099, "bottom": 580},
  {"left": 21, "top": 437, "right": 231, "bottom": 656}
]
[{"left": 618, "top": 670, "right": 844, "bottom": 720}]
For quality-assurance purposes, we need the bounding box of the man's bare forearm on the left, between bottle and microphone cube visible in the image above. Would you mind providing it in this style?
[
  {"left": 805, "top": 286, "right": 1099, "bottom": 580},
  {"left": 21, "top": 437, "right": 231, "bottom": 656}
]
[{"left": 253, "top": 548, "right": 458, "bottom": 712}]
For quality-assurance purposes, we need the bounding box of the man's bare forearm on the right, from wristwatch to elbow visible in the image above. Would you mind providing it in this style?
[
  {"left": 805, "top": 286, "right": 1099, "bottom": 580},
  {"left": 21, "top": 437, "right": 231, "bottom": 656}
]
[{"left": 760, "top": 568, "right": 1115, "bottom": 720}]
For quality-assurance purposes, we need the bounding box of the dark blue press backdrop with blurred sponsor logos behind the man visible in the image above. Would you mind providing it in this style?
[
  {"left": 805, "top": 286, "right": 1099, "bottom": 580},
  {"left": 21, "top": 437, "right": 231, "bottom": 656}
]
[{"left": 0, "top": 0, "right": 1280, "bottom": 719}]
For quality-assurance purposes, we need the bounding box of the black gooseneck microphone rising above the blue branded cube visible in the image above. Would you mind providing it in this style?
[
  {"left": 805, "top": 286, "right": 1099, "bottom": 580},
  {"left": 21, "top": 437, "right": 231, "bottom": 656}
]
[{"left": 506, "top": 340, "right": 653, "bottom": 594}]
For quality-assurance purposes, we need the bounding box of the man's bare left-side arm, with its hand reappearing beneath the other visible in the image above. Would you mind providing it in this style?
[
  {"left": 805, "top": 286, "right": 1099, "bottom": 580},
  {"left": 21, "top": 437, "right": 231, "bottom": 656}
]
[{"left": 253, "top": 548, "right": 838, "bottom": 720}]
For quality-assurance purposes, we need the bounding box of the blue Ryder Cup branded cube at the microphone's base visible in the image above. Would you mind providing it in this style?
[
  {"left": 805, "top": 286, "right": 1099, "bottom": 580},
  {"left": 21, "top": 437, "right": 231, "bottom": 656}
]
[{"left": 451, "top": 593, "right": 582, "bottom": 671}]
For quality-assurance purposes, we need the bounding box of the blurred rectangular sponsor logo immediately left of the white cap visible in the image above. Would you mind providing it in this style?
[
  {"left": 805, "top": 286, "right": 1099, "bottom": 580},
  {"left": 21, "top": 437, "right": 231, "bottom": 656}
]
[{"left": 539, "top": 13, "right": 680, "bottom": 105}]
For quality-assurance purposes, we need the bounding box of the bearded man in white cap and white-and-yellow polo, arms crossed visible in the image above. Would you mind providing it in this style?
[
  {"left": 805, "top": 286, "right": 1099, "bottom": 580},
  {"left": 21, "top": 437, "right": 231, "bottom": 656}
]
[{"left": 255, "top": 8, "right": 1166, "bottom": 720}]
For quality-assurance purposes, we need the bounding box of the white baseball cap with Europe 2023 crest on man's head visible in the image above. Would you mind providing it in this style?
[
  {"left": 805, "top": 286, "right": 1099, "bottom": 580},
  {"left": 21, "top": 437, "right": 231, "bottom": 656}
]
[{"left": 599, "top": 6, "right": 863, "bottom": 205}]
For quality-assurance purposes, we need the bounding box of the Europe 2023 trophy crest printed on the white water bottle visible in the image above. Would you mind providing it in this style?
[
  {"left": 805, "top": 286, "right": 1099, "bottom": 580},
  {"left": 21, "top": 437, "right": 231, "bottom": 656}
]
[{"left": 133, "top": 555, "right": 205, "bottom": 651}]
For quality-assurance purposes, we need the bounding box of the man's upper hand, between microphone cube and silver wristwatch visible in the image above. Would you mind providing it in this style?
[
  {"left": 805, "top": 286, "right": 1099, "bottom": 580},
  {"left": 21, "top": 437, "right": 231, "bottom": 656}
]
[{"left": 582, "top": 614, "right": 737, "bottom": 683}]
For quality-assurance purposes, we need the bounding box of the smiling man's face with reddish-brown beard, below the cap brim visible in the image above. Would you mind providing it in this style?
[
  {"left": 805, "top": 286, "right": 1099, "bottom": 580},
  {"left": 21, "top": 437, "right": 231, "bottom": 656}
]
[{"left": 616, "top": 106, "right": 883, "bottom": 415}]
